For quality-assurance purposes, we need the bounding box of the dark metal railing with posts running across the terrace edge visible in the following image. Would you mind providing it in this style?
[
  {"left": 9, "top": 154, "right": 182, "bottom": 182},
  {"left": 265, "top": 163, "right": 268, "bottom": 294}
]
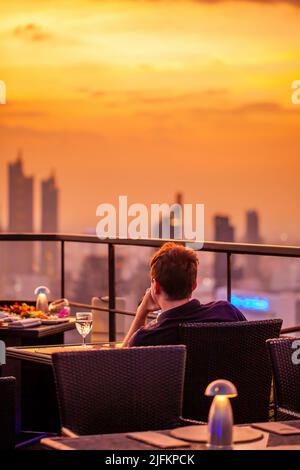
[{"left": 0, "top": 233, "right": 300, "bottom": 341}]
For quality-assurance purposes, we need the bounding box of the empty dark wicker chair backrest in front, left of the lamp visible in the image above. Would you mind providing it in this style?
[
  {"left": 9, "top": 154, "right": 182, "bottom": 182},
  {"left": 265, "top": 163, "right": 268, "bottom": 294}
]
[{"left": 53, "top": 345, "right": 186, "bottom": 434}]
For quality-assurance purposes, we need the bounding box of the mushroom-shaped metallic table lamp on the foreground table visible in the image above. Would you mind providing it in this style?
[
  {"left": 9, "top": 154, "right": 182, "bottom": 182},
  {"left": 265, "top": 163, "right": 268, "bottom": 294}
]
[{"left": 205, "top": 379, "right": 237, "bottom": 450}]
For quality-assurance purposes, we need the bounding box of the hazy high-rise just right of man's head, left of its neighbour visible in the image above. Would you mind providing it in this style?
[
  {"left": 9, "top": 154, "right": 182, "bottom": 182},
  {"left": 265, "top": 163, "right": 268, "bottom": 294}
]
[{"left": 214, "top": 215, "right": 234, "bottom": 288}]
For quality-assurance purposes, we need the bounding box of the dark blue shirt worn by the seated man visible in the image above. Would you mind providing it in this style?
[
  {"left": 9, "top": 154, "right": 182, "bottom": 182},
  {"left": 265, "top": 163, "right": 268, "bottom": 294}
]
[{"left": 129, "top": 299, "right": 246, "bottom": 346}]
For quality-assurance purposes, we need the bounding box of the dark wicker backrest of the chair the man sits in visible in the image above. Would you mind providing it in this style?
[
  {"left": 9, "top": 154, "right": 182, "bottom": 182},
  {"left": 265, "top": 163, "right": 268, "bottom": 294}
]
[{"left": 179, "top": 320, "right": 282, "bottom": 423}]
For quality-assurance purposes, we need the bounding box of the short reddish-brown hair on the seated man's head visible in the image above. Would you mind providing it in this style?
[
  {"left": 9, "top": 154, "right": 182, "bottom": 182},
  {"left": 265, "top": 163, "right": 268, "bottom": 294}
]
[{"left": 150, "top": 242, "right": 198, "bottom": 300}]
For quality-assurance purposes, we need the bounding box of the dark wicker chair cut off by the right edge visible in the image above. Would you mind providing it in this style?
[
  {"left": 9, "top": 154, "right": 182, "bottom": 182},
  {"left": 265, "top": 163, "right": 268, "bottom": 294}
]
[{"left": 267, "top": 338, "right": 300, "bottom": 421}]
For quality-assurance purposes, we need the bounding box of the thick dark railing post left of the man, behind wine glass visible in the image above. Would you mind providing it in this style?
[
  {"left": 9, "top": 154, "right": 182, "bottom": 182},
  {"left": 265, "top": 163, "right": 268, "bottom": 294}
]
[{"left": 108, "top": 243, "right": 116, "bottom": 341}]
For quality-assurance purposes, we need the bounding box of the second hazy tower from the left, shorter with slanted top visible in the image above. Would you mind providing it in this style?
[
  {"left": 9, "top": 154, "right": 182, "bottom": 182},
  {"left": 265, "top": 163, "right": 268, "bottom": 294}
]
[{"left": 41, "top": 175, "right": 59, "bottom": 280}]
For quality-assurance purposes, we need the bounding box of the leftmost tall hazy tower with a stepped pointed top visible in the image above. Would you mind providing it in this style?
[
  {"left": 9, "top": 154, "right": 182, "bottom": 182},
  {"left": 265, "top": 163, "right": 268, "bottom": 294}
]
[{"left": 6, "top": 151, "right": 33, "bottom": 273}]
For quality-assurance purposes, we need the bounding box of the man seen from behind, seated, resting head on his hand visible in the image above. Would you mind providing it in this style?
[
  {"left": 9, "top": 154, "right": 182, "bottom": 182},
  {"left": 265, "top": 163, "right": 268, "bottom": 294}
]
[{"left": 123, "top": 242, "right": 246, "bottom": 347}]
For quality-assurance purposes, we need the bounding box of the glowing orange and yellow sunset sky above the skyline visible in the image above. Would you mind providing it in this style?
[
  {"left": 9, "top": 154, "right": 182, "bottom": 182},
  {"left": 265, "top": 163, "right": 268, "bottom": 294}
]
[{"left": 0, "top": 0, "right": 300, "bottom": 243}]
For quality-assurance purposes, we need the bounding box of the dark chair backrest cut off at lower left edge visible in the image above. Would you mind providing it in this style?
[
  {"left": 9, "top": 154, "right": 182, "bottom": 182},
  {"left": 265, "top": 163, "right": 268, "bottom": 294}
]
[{"left": 0, "top": 377, "right": 16, "bottom": 450}]
